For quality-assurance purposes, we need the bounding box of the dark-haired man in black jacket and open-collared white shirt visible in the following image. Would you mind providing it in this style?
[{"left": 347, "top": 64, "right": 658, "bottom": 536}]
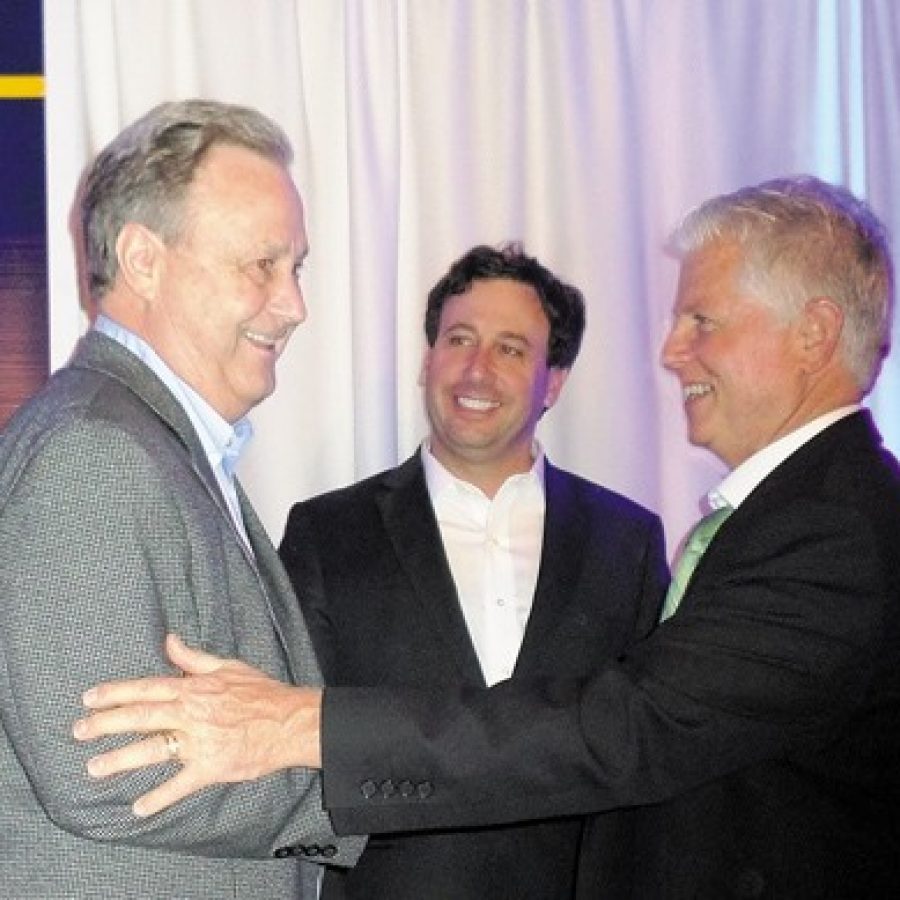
[{"left": 279, "top": 245, "right": 666, "bottom": 900}]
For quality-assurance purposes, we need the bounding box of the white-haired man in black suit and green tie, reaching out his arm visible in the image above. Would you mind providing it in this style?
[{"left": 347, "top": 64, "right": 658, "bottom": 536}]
[{"left": 79, "top": 177, "right": 900, "bottom": 900}]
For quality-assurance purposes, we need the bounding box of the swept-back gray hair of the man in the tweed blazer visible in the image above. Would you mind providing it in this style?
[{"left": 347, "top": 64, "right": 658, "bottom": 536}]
[{"left": 79, "top": 100, "right": 293, "bottom": 299}]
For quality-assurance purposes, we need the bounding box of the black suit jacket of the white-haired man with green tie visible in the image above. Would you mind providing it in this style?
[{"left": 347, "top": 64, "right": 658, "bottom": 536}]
[{"left": 323, "top": 413, "right": 900, "bottom": 900}]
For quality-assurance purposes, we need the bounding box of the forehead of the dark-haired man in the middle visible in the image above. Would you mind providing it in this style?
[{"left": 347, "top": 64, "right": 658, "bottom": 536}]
[{"left": 441, "top": 278, "right": 550, "bottom": 332}]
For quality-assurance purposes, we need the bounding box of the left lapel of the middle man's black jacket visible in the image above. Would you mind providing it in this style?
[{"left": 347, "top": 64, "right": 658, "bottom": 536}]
[{"left": 375, "top": 452, "right": 485, "bottom": 686}]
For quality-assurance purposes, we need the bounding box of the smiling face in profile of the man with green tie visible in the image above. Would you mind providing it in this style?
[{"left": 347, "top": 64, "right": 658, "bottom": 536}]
[{"left": 662, "top": 241, "right": 813, "bottom": 468}]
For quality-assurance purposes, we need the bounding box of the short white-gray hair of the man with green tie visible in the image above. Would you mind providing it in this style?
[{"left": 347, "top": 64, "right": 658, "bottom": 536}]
[{"left": 669, "top": 175, "right": 894, "bottom": 393}]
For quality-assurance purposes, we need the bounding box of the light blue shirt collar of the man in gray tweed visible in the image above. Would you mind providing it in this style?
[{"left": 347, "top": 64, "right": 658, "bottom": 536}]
[{"left": 94, "top": 315, "right": 253, "bottom": 478}]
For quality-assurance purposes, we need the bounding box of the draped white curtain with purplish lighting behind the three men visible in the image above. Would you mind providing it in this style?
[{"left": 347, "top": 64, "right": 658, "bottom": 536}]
[{"left": 44, "top": 0, "right": 900, "bottom": 547}]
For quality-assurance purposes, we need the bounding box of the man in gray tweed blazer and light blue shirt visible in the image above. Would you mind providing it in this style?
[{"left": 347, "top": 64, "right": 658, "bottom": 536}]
[{"left": 0, "top": 101, "right": 363, "bottom": 900}]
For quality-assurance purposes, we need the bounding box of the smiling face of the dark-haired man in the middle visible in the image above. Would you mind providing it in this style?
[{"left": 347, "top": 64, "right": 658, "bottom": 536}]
[{"left": 423, "top": 278, "right": 568, "bottom": 496}]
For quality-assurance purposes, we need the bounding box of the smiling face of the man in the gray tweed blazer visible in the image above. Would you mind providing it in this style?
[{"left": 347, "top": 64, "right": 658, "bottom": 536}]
[{"left": 140, "top": 146, "right": 307, "bottom": 422}]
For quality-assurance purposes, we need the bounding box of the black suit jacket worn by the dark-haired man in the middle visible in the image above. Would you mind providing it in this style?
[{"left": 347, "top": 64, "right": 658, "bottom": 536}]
[{"left": 280, "top": 453, "right": 666, "bottom": 900}]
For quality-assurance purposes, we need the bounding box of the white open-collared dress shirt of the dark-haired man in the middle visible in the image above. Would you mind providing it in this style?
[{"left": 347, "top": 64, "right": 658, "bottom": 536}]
[{"left": 421, "top": 443, "right": 545, "bottom": 685}]
